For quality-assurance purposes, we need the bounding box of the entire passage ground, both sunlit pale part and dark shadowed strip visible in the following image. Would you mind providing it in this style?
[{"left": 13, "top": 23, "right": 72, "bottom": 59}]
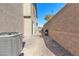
[{"left": 23, "top": 35, "right": 71, "bottom": 56}]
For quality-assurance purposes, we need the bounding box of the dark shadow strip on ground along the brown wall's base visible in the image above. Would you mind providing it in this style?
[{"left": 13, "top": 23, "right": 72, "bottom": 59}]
[{"left": 41, "top": 34, "right": 73, "bottom": 56}]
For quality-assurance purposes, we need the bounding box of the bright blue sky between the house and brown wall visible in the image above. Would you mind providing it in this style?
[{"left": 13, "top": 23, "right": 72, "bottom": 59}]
[{"left": 37, "top": 3, "right": 65, "bottom": 26}]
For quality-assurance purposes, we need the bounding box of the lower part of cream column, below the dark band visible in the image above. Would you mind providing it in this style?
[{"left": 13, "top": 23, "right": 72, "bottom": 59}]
[{"left": 24, "top": 18, "right": 32, "bottom": 37}]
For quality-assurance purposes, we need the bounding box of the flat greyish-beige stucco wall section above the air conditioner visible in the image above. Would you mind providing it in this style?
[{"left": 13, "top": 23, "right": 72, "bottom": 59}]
[{"left": 0, "top": 3, "right": 24, "bottom": 33}]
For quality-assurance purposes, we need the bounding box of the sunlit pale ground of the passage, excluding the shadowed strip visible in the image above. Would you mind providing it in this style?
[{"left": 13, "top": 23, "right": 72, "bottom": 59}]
[{"left": 23, "top": 36, "right": 54, "bottom": 56}]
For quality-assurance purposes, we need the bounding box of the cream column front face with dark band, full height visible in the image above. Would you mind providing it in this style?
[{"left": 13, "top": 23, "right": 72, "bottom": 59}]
[{"left": 23, "top": 3, "right": 32, "bottom": 37}]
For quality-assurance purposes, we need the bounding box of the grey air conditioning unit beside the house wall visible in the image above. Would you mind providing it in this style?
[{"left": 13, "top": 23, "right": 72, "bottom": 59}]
[{"left": 0, "top": 32, "right": 23, "bottom": 56}]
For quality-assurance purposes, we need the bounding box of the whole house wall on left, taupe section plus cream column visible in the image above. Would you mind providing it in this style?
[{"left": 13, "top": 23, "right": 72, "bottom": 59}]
[{"left": 0, "top": 3, "right": 36, "bottom": 36}]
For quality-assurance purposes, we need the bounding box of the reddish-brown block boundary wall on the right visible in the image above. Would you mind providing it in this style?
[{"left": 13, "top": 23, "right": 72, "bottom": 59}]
[{"left": 44, "top": 3, "right": 79, "bottom": 55}]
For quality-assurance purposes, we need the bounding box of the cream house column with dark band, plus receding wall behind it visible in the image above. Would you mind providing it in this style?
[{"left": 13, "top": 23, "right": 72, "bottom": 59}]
[{"left": 23, "top": 3, "right": 36, "bottom": 37}]
